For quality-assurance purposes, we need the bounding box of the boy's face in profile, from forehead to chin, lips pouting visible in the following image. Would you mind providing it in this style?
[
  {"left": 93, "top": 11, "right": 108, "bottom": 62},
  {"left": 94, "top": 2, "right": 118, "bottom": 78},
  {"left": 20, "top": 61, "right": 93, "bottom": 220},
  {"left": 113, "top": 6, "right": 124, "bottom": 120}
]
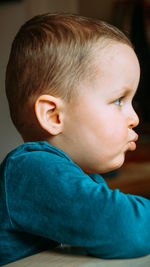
[{"left": 60, "top": 43, "right": 140, "bottom": 173}]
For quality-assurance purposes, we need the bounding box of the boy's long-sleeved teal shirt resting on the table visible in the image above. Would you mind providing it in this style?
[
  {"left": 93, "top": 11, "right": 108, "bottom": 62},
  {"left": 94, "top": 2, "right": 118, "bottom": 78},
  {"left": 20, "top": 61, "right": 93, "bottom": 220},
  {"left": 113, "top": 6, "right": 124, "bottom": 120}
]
[{"left": 0, "top": 142, "right": 150, "bottom": 265}]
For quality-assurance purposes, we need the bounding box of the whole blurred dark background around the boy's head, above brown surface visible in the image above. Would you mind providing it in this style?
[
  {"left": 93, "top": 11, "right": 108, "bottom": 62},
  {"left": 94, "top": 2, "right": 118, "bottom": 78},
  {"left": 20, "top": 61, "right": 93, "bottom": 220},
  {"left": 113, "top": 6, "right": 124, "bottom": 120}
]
[{"left": 0, "top": 0, "right": 150, "bottom": 176}]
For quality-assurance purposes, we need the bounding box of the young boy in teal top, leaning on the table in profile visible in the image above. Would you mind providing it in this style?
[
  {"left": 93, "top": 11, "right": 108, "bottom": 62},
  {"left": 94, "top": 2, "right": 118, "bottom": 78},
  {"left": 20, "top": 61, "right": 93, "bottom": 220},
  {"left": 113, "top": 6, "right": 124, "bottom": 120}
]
[{"left": 0, "top": 14, "right": 150, "bottom": 265}]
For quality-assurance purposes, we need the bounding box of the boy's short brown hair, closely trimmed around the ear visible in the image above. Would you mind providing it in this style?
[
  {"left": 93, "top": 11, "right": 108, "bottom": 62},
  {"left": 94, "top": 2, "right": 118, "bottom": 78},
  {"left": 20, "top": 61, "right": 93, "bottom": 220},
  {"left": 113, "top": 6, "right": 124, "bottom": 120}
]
[{"left": 6, "top": 14, "right": 132, "bottom": 138}]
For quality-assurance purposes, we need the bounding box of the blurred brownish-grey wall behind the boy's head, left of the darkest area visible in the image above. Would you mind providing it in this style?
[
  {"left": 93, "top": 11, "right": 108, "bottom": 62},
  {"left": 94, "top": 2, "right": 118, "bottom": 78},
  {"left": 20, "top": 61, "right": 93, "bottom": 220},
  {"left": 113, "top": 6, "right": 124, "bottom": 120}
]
[{"left": 0, "top": 0, "right": 114, "bottom": 162}]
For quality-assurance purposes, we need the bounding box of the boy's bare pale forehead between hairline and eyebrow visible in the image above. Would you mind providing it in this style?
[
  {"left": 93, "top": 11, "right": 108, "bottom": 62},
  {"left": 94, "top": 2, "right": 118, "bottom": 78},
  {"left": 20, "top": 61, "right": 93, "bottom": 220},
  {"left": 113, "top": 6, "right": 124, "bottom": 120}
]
[{"left": 93, "top": 42, "right": 140, "bottom": 87}]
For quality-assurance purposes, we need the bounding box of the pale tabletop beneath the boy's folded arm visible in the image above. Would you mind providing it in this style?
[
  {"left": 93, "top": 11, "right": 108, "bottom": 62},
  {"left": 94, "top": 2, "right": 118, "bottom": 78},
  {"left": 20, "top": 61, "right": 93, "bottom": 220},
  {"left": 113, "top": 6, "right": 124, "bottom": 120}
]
[{"left": 5, "top": 247, "right": 150, "bottom": 267}]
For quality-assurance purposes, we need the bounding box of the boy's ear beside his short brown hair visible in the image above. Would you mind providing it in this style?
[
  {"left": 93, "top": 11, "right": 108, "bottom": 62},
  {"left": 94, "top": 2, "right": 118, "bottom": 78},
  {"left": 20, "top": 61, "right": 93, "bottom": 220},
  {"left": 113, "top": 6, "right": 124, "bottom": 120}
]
[{"left": 35, "top": 95, "right": 63, "bottom": 135}]
